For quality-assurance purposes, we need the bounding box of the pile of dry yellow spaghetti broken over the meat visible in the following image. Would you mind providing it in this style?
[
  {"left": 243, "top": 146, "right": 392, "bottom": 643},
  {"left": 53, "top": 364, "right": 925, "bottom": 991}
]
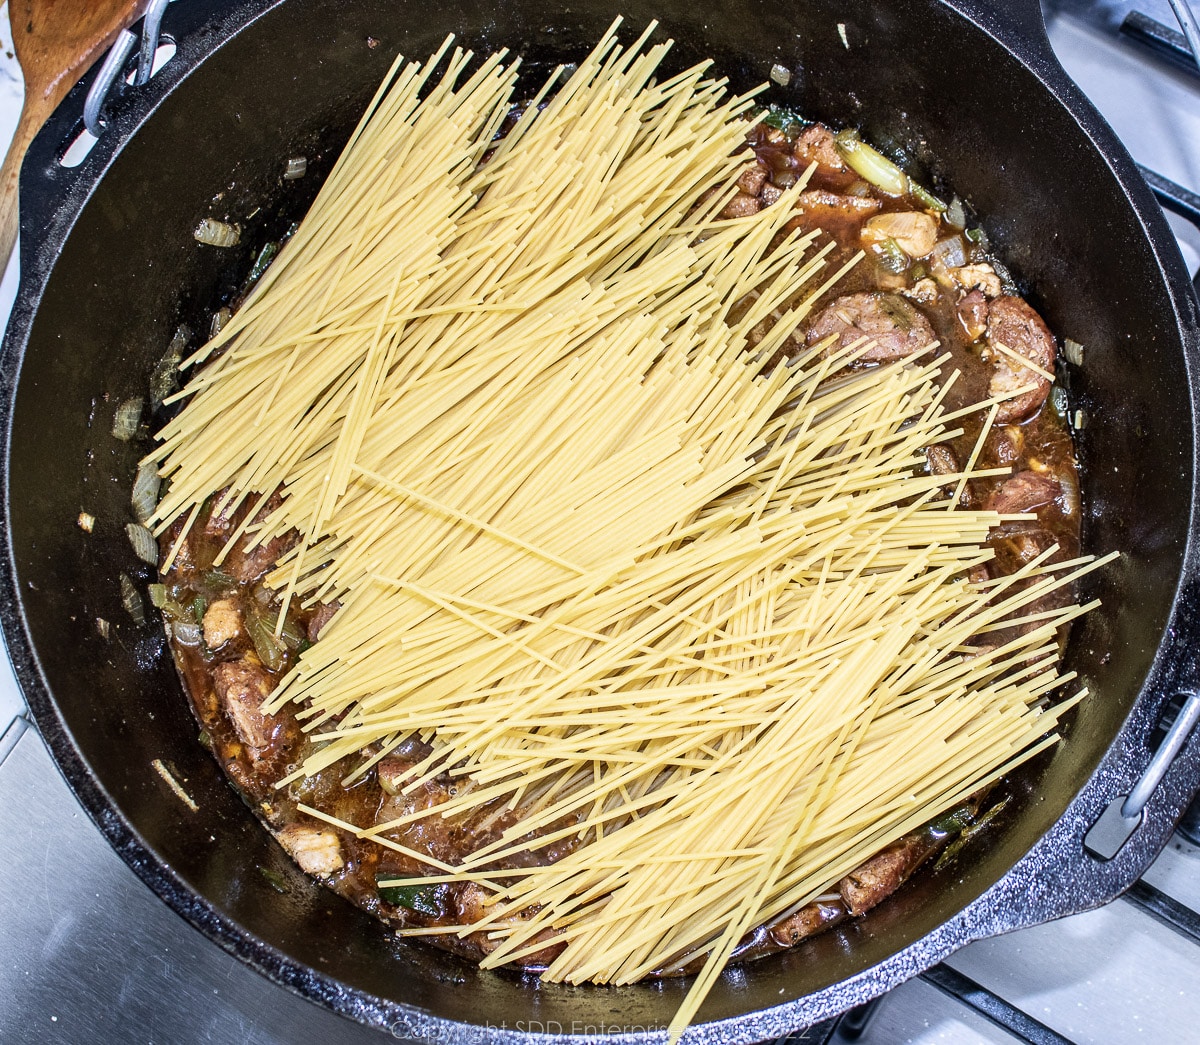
[{"left": 152, "top": 25, "right": 1097, "bottom": 1037}]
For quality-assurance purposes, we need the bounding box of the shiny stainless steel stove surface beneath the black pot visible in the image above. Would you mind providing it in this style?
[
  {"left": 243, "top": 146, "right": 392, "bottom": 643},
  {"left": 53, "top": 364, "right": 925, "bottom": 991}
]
[{"left": 0, "top": 0, "right": 1200, "bottom": 1045}]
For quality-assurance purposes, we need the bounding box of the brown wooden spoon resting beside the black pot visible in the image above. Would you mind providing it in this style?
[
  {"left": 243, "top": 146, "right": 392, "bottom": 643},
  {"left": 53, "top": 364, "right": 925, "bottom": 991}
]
[{"left": 0, "top": 0, "right": 148, "bottom": 270}]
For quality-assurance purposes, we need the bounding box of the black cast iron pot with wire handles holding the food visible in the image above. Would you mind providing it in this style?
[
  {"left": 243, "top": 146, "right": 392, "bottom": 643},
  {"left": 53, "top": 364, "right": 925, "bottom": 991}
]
[{"left": 0, "top": 0, "right": 1200, "bottom": 1043}]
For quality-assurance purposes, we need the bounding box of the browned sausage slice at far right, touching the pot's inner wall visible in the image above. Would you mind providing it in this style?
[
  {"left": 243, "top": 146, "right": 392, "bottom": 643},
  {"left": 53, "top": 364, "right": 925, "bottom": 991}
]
[{"left": 988, "top": 296, "right": 1055, "bottom": 424}]
